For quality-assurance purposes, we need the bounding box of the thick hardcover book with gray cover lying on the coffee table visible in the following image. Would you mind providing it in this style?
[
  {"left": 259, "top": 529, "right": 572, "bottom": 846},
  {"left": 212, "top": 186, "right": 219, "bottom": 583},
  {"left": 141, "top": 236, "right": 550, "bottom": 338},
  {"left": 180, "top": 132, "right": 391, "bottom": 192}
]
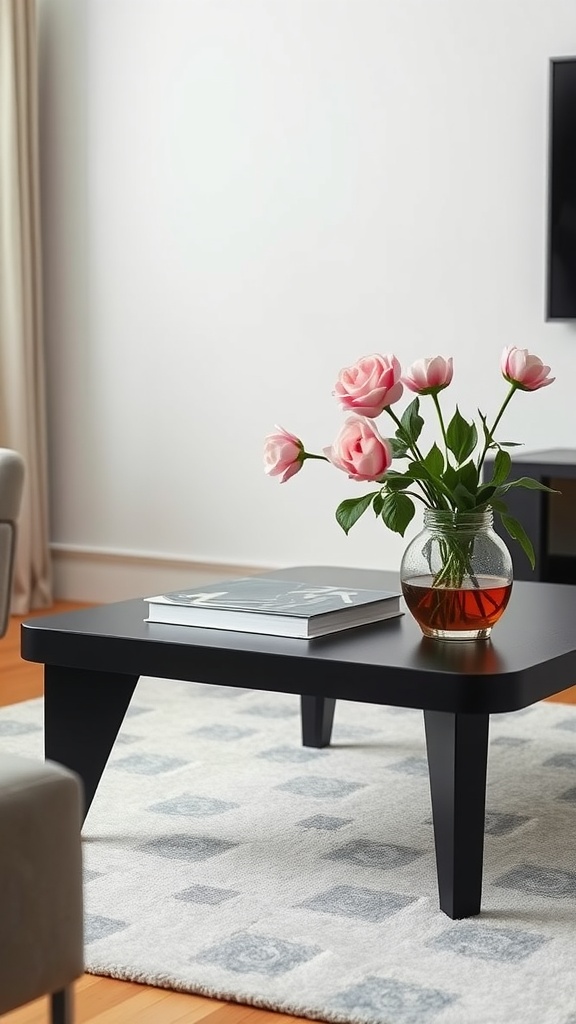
[{"left": 145, "top": 577, "right": 403, "bottom": 640}]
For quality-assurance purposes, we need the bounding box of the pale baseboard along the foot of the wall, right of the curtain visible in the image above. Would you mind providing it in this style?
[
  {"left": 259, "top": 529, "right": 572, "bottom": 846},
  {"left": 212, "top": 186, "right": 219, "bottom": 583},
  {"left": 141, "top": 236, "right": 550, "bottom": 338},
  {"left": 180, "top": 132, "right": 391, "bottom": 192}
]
[{"left": 50, "top": 544, "right": 270, "bottom": 604}]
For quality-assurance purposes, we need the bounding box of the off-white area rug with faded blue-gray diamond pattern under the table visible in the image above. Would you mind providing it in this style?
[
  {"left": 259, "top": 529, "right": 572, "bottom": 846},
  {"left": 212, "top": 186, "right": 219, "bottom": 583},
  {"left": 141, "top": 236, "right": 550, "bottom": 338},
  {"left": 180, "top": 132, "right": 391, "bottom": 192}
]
[{"left": 0, "top": 679, "right": 576, "bottom": 1024}]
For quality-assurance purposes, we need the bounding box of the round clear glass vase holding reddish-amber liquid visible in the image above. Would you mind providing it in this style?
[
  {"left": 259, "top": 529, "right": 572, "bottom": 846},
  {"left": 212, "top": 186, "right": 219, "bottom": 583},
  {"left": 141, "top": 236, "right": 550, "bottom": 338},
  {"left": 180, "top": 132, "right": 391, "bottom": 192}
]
[{"left": 400, "top": 509, "right": 512, "bottom": 640}]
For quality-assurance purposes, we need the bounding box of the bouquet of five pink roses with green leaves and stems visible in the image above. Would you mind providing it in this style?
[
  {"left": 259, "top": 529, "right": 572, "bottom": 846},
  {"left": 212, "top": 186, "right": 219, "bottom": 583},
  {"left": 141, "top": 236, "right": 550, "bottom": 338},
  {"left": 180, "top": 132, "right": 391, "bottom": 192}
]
[{"left": 264, "top": 346, "right": 554, "bottom": 634}]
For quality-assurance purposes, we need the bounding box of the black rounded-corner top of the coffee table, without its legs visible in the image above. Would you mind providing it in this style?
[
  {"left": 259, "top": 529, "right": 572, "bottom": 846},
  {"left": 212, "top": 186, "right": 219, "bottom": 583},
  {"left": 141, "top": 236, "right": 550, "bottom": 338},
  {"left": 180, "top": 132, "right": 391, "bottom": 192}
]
[{"left": 22, "top": 566, "right": 576, "bottom": 714}]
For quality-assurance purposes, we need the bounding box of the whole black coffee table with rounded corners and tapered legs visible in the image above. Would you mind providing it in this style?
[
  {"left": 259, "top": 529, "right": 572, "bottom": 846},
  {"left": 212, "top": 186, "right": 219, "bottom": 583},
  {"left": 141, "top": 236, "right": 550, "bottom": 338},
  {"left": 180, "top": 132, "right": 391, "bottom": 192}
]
[{"left": 22, "top": 566, "right": 576, "bottom": 918}]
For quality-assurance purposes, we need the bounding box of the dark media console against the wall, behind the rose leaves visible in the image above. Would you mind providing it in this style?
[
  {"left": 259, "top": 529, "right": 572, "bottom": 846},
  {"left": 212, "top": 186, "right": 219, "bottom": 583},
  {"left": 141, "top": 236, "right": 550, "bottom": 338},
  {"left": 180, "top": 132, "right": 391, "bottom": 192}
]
[{"left": 484, "top": 449, "right": 576, "bottom": 584}]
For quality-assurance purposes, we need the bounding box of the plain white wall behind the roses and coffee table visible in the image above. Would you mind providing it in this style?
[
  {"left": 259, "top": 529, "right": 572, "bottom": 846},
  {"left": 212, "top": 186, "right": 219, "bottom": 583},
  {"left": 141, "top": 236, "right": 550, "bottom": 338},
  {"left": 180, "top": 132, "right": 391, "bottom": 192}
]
[{"left": 40, "top": 0, "right": 576, "bottom": 598}]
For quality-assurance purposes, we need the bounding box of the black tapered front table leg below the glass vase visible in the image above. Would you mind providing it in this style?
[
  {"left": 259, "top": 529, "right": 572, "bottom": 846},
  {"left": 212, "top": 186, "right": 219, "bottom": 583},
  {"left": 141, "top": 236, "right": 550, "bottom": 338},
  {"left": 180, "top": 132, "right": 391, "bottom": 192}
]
[{"left": 424, "top": 711, "right": 489, "bottom": 919}]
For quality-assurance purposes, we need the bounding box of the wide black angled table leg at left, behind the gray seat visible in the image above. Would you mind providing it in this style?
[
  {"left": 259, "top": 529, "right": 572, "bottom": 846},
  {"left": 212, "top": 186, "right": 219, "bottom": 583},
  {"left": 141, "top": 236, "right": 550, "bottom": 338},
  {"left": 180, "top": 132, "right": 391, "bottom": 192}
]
[{"left": 44, "top": 665, "right": 138, "bottom": 815}]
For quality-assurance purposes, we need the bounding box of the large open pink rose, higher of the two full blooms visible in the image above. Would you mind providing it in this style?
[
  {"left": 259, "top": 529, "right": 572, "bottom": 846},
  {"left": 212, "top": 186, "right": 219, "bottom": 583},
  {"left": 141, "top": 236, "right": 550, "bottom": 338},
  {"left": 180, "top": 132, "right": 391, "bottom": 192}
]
[{"left": 332, "top": 355, "right": 404, "bottom": 420}]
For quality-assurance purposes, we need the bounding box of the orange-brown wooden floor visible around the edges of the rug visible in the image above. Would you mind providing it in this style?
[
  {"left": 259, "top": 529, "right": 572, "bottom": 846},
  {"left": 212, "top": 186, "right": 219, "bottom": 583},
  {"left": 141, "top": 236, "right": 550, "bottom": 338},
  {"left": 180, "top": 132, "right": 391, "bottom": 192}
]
[{"left": 0, "top": 602, "right": 576, "bottom": 1024}]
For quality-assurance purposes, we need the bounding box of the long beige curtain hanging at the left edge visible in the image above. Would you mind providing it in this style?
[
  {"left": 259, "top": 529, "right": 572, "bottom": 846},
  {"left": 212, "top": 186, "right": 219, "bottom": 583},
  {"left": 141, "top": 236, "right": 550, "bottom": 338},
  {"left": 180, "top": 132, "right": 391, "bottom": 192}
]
[{"left": 0, "top": 0, "right": 51, "bottom": 613}]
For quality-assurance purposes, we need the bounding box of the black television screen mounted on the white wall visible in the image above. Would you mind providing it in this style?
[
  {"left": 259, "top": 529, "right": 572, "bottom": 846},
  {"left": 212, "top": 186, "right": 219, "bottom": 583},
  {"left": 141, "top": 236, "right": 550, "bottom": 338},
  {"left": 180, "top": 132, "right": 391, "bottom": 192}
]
[{"left": 546, "top": 57, "right": 576, "bottom": 319}]
